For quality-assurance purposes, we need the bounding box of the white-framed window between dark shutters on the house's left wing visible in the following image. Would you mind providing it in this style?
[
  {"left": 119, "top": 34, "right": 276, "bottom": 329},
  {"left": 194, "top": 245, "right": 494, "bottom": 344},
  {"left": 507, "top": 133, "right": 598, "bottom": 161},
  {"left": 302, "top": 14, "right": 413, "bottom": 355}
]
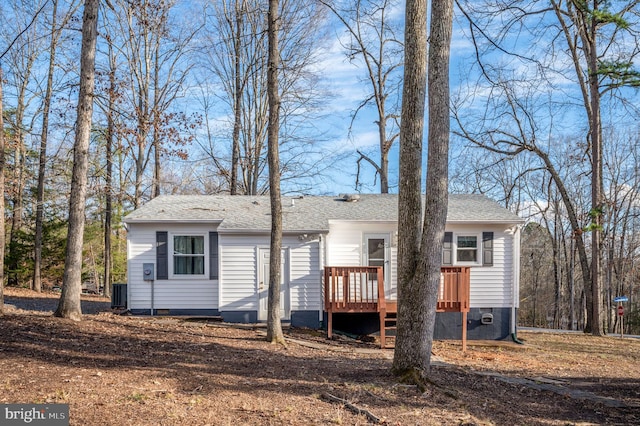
[{"left": 170, "top": 234, "right": 207, "bottom": 277}]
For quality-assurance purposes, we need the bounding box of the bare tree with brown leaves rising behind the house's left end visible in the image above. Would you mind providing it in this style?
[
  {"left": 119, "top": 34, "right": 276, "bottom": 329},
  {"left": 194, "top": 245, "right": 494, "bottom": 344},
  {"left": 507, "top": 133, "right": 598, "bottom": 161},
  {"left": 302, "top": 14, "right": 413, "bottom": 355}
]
[{"left": 107, "top": 0, "right": 199, "bottom": 207}]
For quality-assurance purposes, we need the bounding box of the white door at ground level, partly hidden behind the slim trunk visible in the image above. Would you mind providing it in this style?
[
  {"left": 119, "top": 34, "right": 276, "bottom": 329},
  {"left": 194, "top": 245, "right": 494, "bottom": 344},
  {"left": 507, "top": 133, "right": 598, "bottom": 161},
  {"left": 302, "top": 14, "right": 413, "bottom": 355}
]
[{"left": 258, "top": 248, "right": 291, "bottom": 321}]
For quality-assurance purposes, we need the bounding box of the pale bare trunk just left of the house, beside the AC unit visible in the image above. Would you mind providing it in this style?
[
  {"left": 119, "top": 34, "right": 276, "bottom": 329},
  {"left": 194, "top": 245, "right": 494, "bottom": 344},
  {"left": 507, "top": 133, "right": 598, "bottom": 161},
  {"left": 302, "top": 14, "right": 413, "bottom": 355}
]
[{"left": 54, "top": 0, "right": 99, "bottom": 321}]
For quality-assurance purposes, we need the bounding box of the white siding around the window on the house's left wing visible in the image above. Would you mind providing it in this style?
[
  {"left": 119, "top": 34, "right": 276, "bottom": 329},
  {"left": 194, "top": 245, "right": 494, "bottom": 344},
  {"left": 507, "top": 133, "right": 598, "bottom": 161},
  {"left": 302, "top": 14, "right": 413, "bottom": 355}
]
[{"left": 127, "top": 224, "right": 218, "bottom": 309}]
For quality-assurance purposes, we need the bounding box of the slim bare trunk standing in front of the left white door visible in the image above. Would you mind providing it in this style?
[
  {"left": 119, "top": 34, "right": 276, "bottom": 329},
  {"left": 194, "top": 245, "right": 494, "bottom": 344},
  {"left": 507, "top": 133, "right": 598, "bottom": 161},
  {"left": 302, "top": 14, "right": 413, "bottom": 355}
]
[{"left": 267, "top": 0, "right": 284, "bottom": 343}]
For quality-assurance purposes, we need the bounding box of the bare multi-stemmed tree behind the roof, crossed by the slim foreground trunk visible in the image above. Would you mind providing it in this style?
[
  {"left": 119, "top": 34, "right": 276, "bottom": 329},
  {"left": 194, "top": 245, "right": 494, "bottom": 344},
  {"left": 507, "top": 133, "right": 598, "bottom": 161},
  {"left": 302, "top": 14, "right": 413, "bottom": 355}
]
[{"left": 199, "top": 0, "right": 327, "bottom": 195}]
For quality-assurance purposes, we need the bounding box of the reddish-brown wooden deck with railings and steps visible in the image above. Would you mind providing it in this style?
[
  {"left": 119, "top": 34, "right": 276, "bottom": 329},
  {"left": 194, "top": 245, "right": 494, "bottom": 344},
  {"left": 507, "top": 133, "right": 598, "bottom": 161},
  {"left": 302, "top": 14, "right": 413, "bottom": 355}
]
[{"left": 324, "top": 266, "right": 470, "bottom": 350}]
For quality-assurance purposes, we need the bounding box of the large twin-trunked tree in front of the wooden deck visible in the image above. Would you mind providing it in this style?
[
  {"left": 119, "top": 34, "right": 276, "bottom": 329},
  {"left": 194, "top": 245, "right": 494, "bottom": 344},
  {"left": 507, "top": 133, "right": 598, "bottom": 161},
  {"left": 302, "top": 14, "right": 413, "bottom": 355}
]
[{"left": 392, "top": 0, "right": 453, "bottom": 386}]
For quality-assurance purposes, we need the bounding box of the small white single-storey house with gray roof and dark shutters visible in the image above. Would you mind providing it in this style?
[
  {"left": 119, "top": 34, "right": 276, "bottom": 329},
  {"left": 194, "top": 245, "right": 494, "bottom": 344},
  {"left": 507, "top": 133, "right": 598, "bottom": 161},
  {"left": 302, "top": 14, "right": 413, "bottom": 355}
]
[{"left": 124, "top": 194, "right": 523, "bottom": 339}]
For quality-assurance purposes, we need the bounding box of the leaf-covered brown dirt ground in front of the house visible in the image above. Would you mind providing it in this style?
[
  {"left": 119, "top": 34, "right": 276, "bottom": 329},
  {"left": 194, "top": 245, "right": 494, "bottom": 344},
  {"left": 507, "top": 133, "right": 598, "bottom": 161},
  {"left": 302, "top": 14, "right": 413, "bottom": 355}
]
[{"left": 0, "top": 288, "right": 640, "bottom": 425}]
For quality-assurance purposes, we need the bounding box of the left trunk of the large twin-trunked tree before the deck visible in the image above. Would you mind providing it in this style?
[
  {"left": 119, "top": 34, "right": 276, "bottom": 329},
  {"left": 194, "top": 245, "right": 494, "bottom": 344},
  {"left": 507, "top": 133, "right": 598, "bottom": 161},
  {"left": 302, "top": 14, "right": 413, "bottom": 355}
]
[{"left": 392, "top": 0, "right": 430, "bottom": 381}]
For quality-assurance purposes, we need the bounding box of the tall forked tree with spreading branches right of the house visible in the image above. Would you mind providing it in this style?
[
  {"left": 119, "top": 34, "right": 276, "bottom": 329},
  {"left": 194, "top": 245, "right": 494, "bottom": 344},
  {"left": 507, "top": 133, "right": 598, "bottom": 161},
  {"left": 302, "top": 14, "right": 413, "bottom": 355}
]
[{"left": 459, "top": 0, "right": 640, "bottom": 335}]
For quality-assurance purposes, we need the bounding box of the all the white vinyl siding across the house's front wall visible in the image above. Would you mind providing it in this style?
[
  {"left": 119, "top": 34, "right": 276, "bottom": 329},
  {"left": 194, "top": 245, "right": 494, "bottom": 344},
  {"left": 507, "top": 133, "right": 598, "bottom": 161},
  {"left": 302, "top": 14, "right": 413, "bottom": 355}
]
[{"left": 127, "top": 222, "right": 517, "bottom": 311}]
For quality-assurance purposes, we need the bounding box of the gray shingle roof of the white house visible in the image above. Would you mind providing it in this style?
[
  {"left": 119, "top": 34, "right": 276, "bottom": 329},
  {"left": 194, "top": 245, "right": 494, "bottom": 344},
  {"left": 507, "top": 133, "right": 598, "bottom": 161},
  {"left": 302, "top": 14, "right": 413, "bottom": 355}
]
[{"left": 124, "top": 194, "right": 523, "bottom": 232}]
